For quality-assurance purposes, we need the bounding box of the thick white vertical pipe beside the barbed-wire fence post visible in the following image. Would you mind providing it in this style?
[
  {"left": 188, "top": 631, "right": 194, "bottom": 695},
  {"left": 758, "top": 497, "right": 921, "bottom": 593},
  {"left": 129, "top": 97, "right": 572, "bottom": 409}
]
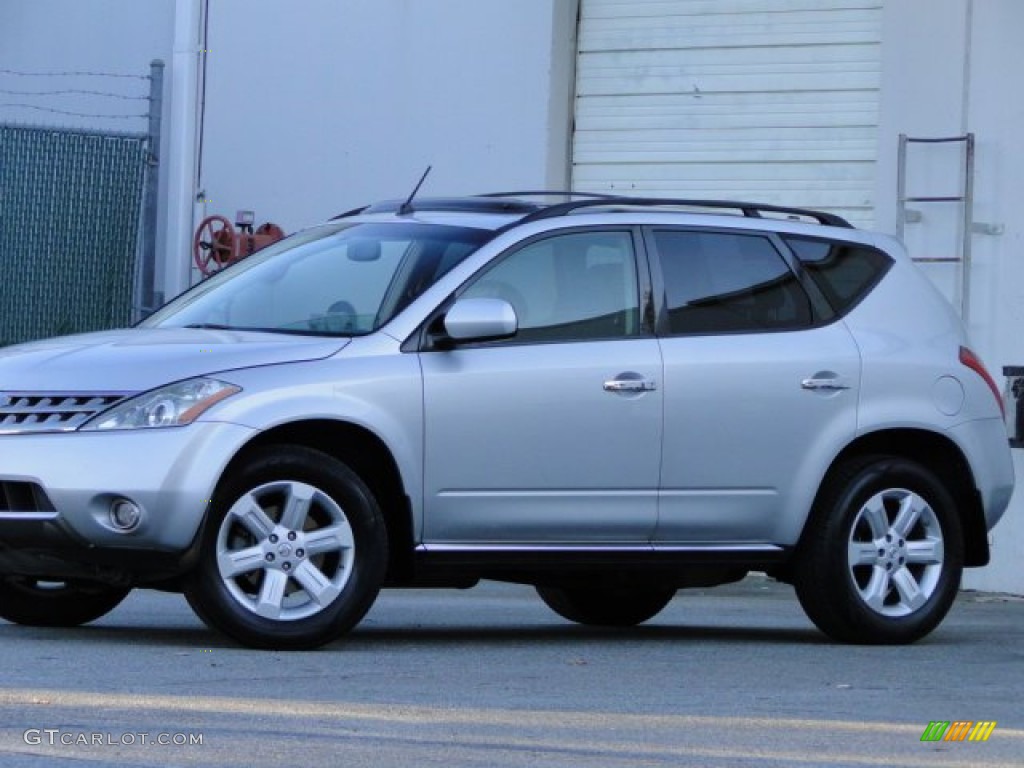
[{"left": 163, "top": 0, "right": 206, "bottom": 300}]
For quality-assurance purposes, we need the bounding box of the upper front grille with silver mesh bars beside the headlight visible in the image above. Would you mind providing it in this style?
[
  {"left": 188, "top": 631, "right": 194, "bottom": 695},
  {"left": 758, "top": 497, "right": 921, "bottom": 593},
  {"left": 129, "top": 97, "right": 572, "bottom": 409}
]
[{"left": 0, "top": 392, "right": 127, "bottom": 434}]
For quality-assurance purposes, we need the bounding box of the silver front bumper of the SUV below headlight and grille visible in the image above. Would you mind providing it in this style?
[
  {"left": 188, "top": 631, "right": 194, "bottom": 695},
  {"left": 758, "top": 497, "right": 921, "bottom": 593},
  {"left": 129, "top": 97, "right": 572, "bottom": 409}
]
[{"left": 0, "top": 422, "right": 255, "bottom": 575}]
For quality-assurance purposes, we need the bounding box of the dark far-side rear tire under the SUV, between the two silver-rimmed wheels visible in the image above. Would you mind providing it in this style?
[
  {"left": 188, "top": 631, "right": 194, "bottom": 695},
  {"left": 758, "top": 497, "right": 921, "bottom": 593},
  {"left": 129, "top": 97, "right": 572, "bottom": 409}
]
[{"left": 537, "top": 587, "right": 676, "bottom": 627}]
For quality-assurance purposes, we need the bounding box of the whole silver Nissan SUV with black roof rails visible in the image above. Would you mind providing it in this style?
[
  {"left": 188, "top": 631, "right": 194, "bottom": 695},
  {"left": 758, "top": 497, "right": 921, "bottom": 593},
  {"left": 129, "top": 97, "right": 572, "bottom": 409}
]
[{"left": 0, "top": 193, "right": 1014, "bottom": 648}]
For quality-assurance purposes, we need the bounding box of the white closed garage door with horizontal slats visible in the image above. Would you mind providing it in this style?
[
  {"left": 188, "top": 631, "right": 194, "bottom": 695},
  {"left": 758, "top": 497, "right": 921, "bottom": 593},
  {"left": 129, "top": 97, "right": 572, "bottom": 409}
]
[{"left": 572, "top": 0, "right": 882, "bottom": 225}]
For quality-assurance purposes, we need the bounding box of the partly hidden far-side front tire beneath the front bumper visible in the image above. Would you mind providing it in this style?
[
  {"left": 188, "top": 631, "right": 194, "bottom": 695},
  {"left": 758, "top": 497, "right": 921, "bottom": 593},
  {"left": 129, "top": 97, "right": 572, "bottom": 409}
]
[{"left": 0, "top": 575, "right": 131, "bottom": 627}]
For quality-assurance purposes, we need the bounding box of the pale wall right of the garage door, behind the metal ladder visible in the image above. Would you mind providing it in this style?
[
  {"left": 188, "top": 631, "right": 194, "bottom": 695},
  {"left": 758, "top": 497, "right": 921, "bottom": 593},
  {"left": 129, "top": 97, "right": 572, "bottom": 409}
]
[{"left": 876, "top": 0, "right": 1024, "bottom": 593}]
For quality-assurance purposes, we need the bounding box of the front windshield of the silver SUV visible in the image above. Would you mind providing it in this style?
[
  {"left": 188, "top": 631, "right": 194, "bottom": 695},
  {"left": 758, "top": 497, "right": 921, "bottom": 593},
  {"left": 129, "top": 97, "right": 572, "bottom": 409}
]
[{"left": 140, "top": 222, "right": 494, "bottom": 336}]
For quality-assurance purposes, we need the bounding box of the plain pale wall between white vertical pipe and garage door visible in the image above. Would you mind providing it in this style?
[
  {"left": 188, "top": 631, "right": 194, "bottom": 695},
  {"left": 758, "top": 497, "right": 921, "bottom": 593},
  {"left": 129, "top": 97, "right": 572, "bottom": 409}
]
[{"left": 190, "top": 0, "right": 575, "bottom": 288}]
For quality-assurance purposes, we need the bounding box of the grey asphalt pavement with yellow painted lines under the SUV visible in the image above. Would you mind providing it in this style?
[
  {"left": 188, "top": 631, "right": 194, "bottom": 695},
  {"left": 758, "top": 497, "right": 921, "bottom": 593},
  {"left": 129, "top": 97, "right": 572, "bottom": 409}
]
[{"left": 0, "top": 575, "right": 1024, "bottom": 768}]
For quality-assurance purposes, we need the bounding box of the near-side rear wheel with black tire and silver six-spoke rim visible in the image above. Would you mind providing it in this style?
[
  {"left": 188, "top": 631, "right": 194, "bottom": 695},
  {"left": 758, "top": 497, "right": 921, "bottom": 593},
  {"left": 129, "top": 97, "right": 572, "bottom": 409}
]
[{"left": 794, "top": 456, "right": 964, "bottom": 645}]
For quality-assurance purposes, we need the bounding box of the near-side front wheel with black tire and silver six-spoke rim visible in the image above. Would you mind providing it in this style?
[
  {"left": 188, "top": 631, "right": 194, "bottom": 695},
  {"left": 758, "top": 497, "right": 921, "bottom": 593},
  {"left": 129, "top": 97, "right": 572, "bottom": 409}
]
[{"left": 185, "top": 445, "right": 388, "bottom": 650}]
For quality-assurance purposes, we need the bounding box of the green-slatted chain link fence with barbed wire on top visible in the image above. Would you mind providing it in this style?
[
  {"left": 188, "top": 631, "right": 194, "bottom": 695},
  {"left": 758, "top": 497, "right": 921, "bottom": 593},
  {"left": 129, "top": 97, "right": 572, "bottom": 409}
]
[{"left": 0, "top": 62, "right": 163, "bottom": 345}]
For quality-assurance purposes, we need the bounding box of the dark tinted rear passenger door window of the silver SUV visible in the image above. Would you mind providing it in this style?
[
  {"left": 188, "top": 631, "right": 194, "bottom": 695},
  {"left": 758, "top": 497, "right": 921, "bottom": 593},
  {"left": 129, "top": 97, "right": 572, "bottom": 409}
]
[{"left": 653, "top": 229, "right": 813, "bottom": 334}]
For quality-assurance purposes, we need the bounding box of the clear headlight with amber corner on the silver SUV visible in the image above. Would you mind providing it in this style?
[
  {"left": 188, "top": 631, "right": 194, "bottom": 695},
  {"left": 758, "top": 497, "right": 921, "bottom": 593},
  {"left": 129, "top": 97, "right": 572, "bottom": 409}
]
[{"left": 79, "top": 379, "right": 242, "bottom": 430}]
